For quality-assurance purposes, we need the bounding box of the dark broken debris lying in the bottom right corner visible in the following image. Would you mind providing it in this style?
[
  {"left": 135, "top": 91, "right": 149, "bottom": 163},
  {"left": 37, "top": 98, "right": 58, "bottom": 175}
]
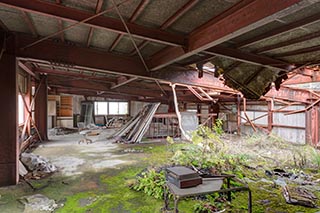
[{"left": 282, "top": 186, "right": 317, "bottom": 208}]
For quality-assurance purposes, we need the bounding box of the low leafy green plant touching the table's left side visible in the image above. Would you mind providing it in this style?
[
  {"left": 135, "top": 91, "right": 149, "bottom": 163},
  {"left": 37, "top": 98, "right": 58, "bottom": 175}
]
[{"left": 132, "top": 169, "right": 165, "bottom": 199}]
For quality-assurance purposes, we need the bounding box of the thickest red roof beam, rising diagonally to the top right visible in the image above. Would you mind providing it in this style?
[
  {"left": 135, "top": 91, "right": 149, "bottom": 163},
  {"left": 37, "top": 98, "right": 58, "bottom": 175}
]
[{"left": 148, "top": 0, "right": 306, "bottom": 71}]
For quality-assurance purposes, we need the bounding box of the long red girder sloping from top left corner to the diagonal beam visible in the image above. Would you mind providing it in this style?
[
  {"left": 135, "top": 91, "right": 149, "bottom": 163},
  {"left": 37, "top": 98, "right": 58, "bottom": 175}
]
[{"left": 0, "top": 0, "right": 185, "bottom": 46}]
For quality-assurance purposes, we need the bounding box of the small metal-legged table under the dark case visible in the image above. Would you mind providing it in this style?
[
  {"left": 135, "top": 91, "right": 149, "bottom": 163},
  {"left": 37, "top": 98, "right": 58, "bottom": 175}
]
[{"left": 163, "top": 175, "right": 252, "bottom": 213}]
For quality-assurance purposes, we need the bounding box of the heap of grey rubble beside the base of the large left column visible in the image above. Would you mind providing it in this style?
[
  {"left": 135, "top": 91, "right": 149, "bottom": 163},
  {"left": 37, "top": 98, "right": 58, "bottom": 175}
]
[{"left": 21, "top": 153, "right": 57, "bottom": 177}]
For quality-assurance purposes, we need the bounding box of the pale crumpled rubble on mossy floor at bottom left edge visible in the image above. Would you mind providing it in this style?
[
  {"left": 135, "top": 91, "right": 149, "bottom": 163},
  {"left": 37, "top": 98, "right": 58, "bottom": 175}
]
[{"left": 19, "top": 194, "right": 58, "bottom": 213}]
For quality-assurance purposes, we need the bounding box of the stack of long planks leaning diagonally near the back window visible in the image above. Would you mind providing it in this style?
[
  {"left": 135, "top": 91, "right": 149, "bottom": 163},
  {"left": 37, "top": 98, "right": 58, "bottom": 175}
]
[{"left": 110, "top": 103, "right": 160, "bottom": 143}]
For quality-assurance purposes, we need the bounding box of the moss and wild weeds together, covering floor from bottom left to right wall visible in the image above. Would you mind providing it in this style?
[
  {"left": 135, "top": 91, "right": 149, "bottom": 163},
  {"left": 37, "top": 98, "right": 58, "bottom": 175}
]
[{"left": 0, "top": 127, "right": 320, "bottom": 213}]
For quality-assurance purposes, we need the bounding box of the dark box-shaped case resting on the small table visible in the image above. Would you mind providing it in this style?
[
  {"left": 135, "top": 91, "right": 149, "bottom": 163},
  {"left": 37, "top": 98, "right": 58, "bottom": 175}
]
[{"left": 166, "top": 166, "right": 202, "bottom": 188}]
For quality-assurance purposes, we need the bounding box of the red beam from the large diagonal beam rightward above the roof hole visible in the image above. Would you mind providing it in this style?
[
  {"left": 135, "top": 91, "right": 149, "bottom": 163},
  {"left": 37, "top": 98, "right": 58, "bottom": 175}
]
[{"left": 206, "top": 46, "right": 292, "bottom": 71}]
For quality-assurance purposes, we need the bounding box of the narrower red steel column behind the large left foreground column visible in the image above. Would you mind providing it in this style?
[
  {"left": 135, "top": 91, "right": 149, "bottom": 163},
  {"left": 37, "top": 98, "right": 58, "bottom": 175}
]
[{"left": 35, "top": 75, "right": 48, "bottom": 140}]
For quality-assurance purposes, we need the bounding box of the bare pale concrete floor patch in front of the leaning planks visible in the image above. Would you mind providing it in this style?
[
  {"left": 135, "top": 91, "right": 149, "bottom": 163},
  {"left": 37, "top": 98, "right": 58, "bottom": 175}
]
[{"left": 33, "top": 129, "right": 133, "bottom": 176}]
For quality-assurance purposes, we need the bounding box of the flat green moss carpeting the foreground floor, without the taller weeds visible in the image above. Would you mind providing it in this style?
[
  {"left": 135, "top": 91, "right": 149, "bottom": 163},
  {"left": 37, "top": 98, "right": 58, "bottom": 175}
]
[{"left": 0, "top": 143, "right": 320, "bottom": 213}]
